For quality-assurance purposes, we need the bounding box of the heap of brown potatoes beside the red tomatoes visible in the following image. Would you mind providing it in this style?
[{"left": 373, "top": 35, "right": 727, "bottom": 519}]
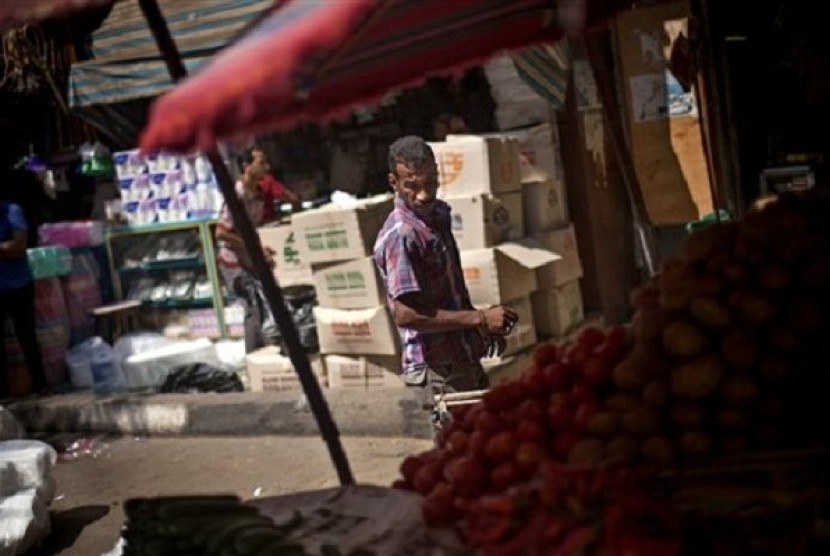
[{"left": 616, "top": 190, "right": 830, "bottom": 463}]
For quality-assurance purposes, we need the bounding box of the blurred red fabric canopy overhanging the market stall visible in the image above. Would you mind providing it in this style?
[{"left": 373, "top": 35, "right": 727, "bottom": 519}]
[{"left": 141, "top": 0, "right": 631, "bottom": 152}]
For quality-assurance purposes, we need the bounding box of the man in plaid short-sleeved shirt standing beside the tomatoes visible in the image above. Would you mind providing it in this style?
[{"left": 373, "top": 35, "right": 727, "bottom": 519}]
[{"left": 374, "top": 136, "right": 518, "bottom": 416}]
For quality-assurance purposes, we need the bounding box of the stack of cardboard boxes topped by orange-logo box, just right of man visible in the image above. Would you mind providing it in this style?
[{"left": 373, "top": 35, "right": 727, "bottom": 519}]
[{"left": 431, "top": 135, "right": 557, "bottom": 378}]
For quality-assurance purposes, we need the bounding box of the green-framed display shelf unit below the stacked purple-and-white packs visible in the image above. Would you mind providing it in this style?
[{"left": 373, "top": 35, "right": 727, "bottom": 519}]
[{"left": 105, "top": 219, "right": 233, "bottom": 337}]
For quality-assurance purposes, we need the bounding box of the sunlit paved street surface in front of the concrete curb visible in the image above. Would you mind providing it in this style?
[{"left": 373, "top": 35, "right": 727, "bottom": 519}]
[{"left": 36, "top": 436, "right": 431, "bottom": 556}]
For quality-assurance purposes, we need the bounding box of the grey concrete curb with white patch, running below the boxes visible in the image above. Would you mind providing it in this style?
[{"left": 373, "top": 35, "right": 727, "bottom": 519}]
[{"left": 7, "top": 387, "right": 431, "bottom": 438}]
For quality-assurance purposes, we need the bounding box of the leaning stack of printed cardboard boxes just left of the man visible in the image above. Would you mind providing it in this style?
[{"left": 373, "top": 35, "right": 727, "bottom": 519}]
[{"left": 291, "top": 195, "right": 401, "bottom": 388}]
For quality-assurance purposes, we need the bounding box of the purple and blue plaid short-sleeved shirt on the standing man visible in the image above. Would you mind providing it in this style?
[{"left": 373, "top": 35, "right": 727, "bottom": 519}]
[{"left": 374, "top": 197, "right": 484, "bottom": 374}]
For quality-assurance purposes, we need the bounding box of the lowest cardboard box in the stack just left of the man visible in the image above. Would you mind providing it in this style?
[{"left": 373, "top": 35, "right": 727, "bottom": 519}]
[{"left": 324, "top": 355, "right": 403, "bottom": 388}]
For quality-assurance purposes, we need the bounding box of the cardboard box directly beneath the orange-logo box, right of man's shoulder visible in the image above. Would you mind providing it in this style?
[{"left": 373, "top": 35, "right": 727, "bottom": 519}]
[{"left": 444, "top": 193, "right": 524, "bottom": 251}]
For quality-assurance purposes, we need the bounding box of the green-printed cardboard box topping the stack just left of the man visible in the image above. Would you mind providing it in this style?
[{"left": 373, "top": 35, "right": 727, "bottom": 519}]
[{"left": 291, "top": 195, "right": 393, "bottom": 264}]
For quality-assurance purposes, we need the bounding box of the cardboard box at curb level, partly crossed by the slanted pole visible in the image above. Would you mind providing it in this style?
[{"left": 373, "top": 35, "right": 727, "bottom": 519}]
[{"left": 245, "top": 346, "right": 326, "bottom": 392}]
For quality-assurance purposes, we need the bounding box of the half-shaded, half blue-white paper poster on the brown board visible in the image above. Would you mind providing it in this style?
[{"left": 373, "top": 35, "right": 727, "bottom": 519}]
[{"left": 630, "top": 70, "right": 697, "bottom": 122}]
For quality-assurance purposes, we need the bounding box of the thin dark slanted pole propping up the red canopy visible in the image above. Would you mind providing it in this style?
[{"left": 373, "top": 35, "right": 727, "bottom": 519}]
[{"left": 139, "top": 0, "right": 355, "bottom": 485}]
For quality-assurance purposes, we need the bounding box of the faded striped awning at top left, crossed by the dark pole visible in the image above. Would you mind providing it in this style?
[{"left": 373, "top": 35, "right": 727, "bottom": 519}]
[{"left": 69, "top": 0, "right": 275, "bottom": 108}]
